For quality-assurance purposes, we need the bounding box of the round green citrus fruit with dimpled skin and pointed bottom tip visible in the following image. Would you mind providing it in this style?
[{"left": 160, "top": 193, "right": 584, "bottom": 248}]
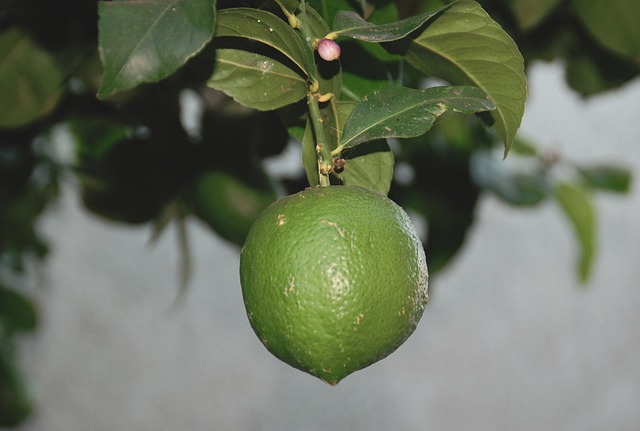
[{"left": 240, "top": 186, "right": 428, "bottom": 385}]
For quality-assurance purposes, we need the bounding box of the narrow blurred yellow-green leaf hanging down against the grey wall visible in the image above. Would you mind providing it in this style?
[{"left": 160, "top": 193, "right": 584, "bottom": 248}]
[{"left": 555, "top": 183, "right": 596, "bottom": 283}]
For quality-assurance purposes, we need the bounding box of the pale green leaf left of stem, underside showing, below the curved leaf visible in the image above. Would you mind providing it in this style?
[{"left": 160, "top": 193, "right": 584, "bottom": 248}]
[{"left": 207, "top": 46, "right": 307, "bottom": 111}]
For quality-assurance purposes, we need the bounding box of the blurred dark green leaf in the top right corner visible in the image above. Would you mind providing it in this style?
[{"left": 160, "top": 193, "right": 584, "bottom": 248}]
[{"left": 573, "top": 0, "right": 640, "bottom": 64}]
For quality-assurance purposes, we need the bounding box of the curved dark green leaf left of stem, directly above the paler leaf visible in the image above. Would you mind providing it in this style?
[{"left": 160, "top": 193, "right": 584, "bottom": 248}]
[{"left": 215, "top": 8, "right": 310, "bottom": 75}]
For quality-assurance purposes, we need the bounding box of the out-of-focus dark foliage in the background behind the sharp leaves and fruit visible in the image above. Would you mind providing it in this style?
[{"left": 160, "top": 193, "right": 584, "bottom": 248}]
[{"left": 0, "top": 0, "right": 640, "bottom": 426}]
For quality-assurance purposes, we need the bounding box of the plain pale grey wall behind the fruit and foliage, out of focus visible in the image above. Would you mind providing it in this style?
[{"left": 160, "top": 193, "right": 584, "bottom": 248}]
[{"left": 13, "top": 64, "right": 640, "bottom": 431}]
